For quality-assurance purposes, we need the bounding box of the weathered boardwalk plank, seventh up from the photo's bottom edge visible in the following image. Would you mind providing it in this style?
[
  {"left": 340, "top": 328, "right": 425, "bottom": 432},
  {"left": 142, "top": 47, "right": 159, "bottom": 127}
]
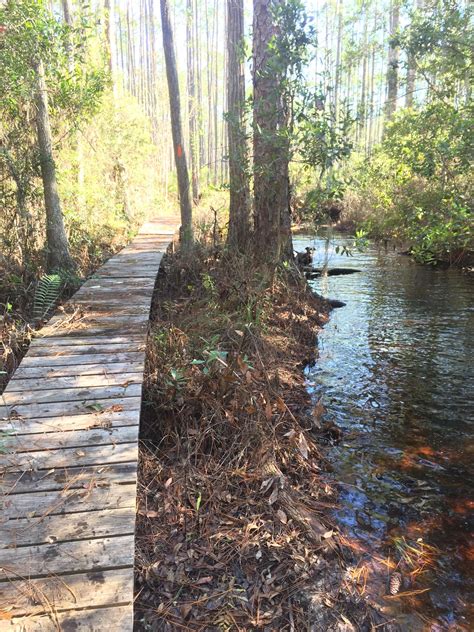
[{"left": 0, "top": 441, "right": 138, "bottom": 472}]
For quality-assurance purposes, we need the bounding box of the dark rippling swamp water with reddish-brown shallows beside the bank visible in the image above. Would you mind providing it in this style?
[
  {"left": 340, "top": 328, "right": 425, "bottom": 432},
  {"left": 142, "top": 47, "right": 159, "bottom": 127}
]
[{"left": 294, "top": 235, "right": 474, "bottom": 632}]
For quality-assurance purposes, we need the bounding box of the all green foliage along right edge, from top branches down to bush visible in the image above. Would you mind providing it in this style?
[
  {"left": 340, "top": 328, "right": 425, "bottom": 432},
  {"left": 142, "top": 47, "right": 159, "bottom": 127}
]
[{"left": 346, "top": 0, "right": 474, "bottom": 264}]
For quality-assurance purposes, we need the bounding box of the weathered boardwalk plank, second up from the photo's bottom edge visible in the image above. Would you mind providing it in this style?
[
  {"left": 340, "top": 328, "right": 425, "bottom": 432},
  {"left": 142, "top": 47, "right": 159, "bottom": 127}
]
[{"left": 0, "top": 568, "right": 133, "bottom": 616}]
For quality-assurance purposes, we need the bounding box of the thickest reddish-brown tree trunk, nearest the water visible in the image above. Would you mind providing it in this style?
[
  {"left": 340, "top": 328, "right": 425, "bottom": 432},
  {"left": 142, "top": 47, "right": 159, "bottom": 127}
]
[{"left": 253, "top": 0, "right": 292, "bottom": 264}]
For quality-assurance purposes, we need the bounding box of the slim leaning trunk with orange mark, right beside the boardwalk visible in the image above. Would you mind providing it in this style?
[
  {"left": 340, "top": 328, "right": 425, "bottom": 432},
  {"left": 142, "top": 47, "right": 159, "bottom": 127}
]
[{"left": 160, "top": 0, "right": 193, "bottom": 251}]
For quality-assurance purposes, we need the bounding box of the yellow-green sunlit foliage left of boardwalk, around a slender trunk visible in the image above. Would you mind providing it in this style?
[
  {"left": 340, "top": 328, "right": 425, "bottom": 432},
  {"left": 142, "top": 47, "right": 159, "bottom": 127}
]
[{"left": 0, "top": 0, "right": 158, "bottom": 275}]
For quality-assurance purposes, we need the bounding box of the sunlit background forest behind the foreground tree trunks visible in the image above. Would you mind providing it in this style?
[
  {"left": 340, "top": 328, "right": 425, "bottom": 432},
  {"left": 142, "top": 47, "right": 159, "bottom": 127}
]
[{"left": 0, "top": 0, "right": 473, "bottom": 276}]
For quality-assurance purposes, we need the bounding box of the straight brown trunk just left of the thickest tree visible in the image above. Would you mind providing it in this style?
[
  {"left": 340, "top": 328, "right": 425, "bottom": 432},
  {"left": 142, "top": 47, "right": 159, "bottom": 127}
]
[{"left": 227, "top": 0, "right": 250, "bottom": 251}]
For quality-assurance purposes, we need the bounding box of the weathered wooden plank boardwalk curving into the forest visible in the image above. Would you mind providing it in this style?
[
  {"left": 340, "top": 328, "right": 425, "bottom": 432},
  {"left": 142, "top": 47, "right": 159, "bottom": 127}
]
[{"left": 0, "top": 218, "right": 177, "bottom": 632}]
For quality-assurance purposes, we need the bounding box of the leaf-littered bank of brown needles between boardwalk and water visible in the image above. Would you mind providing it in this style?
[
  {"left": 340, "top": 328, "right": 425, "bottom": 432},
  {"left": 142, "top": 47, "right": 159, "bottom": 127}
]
[{"left": 135, "top": 249, "right": 392, "bottom": 632}]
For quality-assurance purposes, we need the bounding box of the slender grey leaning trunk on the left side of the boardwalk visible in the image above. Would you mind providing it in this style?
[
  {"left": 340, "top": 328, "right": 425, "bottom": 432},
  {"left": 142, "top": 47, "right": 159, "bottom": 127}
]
[{"left": 33, "top": 60, "right": 74, "bottom": 271}]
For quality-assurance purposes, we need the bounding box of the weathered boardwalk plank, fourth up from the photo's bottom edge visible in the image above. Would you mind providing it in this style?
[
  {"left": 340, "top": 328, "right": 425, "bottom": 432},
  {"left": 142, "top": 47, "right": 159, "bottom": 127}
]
[{"left": 0, "top": 506, "right": 136, "bottom": 552}]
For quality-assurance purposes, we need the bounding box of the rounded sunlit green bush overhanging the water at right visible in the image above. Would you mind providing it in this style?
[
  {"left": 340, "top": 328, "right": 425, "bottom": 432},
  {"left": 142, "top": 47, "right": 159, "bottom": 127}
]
[{"left": 348, "top": 118, "right": 474, "bottom": 263}]
